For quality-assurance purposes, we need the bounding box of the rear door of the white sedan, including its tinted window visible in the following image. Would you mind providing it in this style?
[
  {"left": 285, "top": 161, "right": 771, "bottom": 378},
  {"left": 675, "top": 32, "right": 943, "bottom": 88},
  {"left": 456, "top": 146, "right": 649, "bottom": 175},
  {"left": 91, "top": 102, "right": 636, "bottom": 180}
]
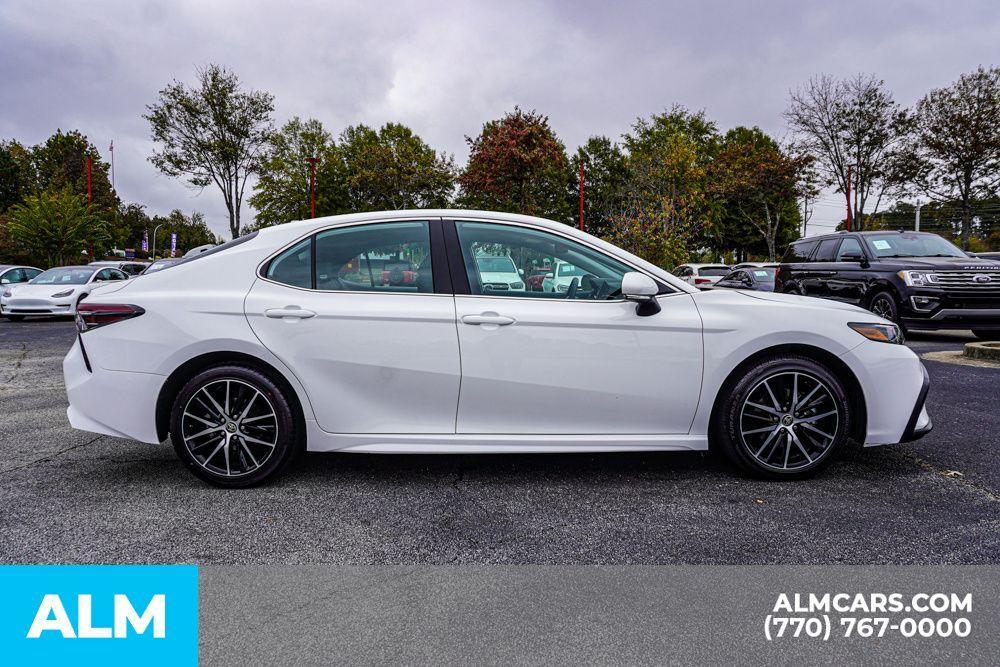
[{"left": 245, "top": 220, "right": 460, "bottom": 433}]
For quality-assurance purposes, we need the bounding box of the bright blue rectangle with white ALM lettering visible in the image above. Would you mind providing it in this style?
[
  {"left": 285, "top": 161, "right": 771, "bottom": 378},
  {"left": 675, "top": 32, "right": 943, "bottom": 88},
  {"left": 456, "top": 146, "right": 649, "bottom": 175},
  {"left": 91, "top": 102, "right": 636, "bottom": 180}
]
[{"left": 0, "top": 565, "right": 198, "bottom": 665}]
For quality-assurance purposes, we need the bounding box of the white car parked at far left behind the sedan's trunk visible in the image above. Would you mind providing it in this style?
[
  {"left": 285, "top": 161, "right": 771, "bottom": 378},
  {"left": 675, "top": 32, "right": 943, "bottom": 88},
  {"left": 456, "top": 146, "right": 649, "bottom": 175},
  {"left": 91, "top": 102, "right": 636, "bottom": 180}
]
[{"left": 0, "top": 266, "right": 129, "bottom": 322}]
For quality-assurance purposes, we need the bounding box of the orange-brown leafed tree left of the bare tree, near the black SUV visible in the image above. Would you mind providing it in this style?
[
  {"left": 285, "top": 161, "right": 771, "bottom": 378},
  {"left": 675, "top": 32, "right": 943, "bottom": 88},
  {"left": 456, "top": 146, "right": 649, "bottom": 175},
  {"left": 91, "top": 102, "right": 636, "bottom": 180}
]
[{"left": 712, "top": 127, "right": 810, "bottom": 262}]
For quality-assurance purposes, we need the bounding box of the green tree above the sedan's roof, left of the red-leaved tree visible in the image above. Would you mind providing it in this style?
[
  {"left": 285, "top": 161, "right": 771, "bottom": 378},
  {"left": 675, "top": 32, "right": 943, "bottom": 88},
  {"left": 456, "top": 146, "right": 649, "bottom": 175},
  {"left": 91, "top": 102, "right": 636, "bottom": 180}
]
[{"left": 340, "top": 123, "right": 455, "bottom": 211}]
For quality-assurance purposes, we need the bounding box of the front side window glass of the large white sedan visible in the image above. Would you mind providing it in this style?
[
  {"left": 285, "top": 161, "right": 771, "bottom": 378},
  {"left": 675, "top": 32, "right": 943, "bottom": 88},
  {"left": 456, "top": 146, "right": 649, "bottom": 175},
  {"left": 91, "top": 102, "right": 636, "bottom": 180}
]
[{"left": 456, "top": 222, "right": 632, "bottom": 301}]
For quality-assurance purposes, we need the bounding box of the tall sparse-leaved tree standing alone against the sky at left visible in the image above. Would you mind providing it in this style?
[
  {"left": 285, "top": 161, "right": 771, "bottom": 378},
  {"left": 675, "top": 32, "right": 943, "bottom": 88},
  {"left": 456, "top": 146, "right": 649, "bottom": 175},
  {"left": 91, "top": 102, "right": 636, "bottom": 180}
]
[{"left": 143, "top": 64, "right": 274, "bottom": 238}]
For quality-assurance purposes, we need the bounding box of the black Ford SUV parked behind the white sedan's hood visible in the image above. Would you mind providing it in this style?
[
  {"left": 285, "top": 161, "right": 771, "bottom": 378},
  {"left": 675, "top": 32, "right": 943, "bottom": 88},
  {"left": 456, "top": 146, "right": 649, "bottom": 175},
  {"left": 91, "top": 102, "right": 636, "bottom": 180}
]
[{"left": 774, "top": 232, "right": 1000, "bottom": 340}]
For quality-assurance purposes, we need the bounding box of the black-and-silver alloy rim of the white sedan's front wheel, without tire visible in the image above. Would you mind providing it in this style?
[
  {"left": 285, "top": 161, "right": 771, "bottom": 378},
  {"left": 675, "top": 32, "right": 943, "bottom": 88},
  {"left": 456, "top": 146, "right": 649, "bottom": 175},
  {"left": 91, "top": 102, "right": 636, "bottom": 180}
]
[{"left": 740, "top": 371, "right": 841, "bottom": 471}]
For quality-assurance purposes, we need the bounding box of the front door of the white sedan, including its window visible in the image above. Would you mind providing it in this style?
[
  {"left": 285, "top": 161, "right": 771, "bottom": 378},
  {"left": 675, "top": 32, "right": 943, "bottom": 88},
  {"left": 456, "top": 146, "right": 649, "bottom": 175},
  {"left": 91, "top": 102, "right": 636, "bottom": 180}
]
[{"left": 449, "top": 221, "right": 702, "bottom": 435}]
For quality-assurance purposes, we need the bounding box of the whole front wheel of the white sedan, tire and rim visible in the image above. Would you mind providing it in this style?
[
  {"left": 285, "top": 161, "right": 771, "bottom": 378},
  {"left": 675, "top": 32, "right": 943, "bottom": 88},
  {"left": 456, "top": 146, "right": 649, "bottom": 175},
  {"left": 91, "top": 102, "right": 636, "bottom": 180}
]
[{"left": 712, "top": 355, "right": 854, "bottom": 479}]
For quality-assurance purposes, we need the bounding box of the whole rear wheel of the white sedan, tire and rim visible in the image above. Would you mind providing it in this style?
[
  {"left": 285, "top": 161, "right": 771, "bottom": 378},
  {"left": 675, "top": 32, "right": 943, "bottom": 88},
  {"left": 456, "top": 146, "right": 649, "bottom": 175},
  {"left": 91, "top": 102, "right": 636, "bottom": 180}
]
[{"left": 170, "top": 365, "right": 302, "bottom": 488}]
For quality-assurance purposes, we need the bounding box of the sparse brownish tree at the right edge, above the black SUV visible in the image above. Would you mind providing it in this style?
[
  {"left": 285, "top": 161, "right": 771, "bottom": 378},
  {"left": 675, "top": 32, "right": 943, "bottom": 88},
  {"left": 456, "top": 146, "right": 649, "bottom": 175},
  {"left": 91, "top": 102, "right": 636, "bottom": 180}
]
[{"left": 912, "top": 67, "right": 1000, "bottom": 250}]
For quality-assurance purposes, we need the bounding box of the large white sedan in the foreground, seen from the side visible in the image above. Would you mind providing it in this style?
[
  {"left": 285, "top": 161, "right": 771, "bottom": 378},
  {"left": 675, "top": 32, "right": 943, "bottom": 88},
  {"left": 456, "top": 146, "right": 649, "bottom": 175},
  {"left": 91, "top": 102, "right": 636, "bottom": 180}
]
[{"left": 63, "top": 210, "right": 931, "bottom": 487}]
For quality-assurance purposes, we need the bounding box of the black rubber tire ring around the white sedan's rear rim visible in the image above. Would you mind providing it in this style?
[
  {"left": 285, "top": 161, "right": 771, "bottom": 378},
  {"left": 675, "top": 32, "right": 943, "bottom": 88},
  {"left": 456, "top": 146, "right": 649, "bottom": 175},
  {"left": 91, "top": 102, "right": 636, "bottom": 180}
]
[{"left": 170, "top": 365, "right": 299, "bottom": 488}]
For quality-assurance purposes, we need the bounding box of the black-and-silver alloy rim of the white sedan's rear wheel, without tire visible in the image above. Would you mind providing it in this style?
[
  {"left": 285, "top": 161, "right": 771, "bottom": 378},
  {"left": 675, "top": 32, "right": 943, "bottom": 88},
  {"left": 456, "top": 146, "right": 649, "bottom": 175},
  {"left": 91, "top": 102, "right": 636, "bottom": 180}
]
[{"left": 181, "top": 379, "right": 278, "bottom": 477}]
